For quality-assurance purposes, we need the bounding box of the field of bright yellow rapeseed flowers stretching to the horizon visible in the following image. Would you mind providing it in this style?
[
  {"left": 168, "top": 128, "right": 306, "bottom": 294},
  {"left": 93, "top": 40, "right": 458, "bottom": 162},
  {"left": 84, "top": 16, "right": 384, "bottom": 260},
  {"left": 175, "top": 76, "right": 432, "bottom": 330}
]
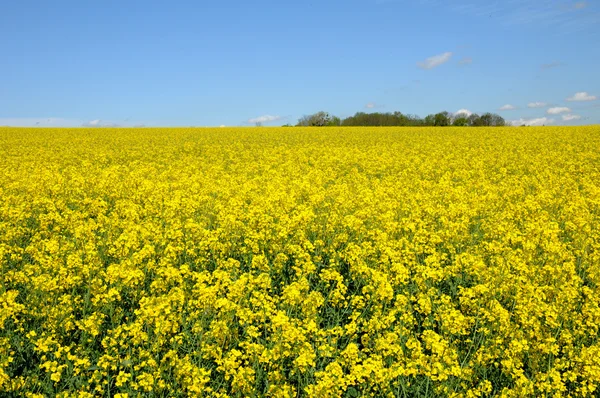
[{"left": 0, "top": 126, "right": 600, "bottom": 398}]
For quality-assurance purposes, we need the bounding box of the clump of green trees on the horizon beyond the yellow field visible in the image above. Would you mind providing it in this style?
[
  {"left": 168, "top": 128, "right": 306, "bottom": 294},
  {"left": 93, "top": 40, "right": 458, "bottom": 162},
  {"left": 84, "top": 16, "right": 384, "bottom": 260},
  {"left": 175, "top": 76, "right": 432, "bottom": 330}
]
[{"left": 288, "top": 111, "right": 507, "bottom": 127}]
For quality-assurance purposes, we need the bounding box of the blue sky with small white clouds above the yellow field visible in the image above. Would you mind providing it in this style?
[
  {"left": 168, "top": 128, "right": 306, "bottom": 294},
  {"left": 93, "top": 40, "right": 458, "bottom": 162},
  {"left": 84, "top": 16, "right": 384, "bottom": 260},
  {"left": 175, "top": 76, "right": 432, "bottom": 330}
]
[{"left": 0, "top": 0, "right": 600, "bottom": 126}]
